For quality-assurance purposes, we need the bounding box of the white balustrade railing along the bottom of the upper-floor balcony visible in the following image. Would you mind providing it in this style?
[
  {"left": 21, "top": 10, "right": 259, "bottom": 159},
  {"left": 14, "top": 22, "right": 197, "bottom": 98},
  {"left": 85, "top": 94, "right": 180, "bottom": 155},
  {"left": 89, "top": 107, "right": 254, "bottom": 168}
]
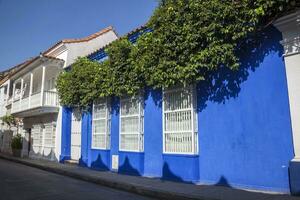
[{"left": 11, "top": 91, "right": 59, "bottom": 114}]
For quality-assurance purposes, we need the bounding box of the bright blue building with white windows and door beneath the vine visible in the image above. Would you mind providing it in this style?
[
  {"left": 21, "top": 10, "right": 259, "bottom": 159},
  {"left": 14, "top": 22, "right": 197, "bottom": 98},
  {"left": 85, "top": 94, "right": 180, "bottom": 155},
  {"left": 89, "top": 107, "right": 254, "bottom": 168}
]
[{"left": 60, "top": 12, "right": 300, "bottom": 193}]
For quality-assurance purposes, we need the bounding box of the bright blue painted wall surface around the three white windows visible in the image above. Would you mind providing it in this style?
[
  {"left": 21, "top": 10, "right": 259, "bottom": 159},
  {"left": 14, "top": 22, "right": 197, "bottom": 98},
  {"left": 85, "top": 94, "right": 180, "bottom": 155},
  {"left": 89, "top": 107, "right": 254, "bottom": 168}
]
[{"left": 62, "top": 28, "right": 293, "bottom": 192}]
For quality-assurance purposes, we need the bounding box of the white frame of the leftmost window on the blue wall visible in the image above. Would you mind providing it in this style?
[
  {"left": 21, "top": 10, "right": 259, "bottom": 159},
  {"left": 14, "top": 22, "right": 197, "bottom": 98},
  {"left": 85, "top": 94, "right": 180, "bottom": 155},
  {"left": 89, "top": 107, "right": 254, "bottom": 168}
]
[{"left": 91, "top": 98, "right": 111, "bottom": 150}]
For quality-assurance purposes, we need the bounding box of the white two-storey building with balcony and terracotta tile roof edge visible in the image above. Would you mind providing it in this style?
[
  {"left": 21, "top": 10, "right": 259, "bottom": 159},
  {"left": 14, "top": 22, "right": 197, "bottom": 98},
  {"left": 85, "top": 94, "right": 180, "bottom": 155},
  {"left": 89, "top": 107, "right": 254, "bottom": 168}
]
[{"left": 0, "top": 27, "right": 117, "bottom": 160}]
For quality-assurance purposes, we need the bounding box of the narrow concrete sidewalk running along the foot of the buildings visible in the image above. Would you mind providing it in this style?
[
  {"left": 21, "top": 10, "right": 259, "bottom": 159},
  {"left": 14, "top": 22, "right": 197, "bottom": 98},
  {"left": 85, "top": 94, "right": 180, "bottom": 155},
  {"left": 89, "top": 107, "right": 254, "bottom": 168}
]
[{"left": 0, "top": 154, "right": 300, "bottom": 200}]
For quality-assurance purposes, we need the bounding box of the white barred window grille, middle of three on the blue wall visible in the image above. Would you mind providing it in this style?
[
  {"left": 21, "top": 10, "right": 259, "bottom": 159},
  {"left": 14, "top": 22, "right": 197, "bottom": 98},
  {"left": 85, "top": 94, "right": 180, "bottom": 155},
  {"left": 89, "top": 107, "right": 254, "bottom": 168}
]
[{"left": 120, "top": 96, "right": 144, "bottom": 152}]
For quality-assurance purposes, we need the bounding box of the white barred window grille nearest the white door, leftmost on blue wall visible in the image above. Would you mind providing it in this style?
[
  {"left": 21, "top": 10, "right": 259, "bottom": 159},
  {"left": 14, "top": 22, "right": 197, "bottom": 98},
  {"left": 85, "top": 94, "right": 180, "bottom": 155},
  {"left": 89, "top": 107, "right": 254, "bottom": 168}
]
[{"left": 92, "top": 99, "right": 111, "bottom": 149}]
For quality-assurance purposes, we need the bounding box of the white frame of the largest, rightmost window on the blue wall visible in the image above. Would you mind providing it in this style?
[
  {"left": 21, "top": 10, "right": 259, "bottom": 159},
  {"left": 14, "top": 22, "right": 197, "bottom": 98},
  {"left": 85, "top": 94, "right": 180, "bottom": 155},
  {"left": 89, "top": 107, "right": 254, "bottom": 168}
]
[{"left": 162, "top": 85, "right": 199, "bottom": 156}]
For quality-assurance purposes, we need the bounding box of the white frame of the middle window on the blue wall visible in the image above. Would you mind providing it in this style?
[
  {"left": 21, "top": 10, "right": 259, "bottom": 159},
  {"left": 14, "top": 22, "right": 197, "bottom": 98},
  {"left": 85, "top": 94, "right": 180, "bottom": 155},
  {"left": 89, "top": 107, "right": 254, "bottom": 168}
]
[{"left": 119, "top": 94, "right": 145, "bottom": 153}]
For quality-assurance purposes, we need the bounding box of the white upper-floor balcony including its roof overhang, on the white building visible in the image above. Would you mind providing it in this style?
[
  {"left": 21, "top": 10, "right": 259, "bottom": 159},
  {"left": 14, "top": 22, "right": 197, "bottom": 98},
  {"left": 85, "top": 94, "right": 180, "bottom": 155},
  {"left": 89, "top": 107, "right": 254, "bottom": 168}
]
[{"left": 0, "top": 55, "right": 64, "bottom": 117}]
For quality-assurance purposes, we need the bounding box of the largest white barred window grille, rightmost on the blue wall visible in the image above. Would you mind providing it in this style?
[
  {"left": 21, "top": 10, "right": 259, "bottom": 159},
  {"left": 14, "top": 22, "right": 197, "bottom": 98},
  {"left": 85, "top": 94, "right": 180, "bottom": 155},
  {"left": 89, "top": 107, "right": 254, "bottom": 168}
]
[{"left": 163, "top": 87, "right": 198, "bottom": 154}]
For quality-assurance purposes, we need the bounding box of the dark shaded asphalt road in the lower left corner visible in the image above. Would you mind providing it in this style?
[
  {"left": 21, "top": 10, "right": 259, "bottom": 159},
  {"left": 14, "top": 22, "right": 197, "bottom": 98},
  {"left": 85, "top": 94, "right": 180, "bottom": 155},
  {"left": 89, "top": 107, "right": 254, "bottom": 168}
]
[{"left": 0, "top": 159, "right": 156, "bottom": 200}]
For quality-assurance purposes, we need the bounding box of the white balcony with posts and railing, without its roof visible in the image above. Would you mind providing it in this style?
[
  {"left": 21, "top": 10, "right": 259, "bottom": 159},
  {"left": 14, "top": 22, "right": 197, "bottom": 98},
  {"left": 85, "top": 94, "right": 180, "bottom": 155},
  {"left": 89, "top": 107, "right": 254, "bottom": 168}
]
[{"left": 7, "top": 59, "right": 61, "bottom": 117}]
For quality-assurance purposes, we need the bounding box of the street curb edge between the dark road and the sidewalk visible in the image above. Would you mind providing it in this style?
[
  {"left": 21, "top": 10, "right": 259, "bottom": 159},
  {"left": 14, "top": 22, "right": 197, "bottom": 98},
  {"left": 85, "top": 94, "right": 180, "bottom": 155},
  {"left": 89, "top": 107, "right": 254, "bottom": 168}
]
[{"left": 0, "top": 154, "right": 216, "bottom": 200}]
